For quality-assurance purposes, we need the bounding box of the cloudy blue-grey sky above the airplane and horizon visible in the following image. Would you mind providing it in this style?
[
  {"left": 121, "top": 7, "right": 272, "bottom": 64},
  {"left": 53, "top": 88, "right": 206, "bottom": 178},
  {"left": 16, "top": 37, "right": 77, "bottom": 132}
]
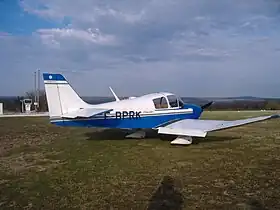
[{"left": 0, "top": 0, "right": 280, "bottom": 97}]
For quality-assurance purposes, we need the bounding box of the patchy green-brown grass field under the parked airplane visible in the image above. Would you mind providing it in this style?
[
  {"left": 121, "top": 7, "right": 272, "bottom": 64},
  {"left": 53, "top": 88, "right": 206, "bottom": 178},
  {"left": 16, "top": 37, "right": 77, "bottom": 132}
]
[{"left": 0, "top": 112, "right": 280, "bottom": 210}]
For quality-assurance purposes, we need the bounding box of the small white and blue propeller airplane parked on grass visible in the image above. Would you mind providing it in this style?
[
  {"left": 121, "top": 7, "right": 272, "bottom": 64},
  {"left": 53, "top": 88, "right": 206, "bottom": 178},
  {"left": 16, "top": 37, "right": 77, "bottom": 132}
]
[{"left": 43, "top": 73, "right": 279, "bottom": 145}]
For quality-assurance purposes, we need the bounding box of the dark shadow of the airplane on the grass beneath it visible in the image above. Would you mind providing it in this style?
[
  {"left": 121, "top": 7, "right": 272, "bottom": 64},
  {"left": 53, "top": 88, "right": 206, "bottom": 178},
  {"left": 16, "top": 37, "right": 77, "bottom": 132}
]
[{"left": 85, "top": 129, "right": 241, "bottom": 144}]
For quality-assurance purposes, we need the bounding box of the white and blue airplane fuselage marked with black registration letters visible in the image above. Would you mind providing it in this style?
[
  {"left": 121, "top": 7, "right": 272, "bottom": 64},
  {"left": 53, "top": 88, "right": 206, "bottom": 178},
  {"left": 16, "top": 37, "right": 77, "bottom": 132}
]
[{"left": 51, "top": 93, "right": 202, "bottom": 129}]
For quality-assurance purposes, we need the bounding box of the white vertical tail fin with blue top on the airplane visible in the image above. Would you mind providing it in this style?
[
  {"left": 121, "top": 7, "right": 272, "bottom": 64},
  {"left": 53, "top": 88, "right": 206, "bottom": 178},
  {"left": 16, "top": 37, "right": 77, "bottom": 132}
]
[{"left": 43, "top": 73, "right": 88, "bottom": 118}]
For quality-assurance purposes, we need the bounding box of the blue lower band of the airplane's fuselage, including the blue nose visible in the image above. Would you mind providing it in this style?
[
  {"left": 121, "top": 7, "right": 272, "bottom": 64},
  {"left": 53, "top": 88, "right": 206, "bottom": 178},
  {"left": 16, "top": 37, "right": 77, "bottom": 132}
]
[{"left": 51, "top": 105, "right": 202, "bottom": 128}]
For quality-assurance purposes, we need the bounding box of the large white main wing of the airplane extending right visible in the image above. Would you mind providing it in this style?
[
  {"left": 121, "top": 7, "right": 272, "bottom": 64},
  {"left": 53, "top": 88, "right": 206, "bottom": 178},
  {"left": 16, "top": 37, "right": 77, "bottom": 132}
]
[{"left": 158, "top": 115, "right": 280, "bottom": 137}]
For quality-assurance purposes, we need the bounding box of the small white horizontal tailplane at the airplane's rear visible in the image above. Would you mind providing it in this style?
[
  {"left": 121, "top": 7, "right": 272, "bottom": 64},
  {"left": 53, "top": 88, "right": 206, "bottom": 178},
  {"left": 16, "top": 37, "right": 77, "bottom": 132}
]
[{"left": 62, "top": 108, "right": 113, "bottom": 119}]
